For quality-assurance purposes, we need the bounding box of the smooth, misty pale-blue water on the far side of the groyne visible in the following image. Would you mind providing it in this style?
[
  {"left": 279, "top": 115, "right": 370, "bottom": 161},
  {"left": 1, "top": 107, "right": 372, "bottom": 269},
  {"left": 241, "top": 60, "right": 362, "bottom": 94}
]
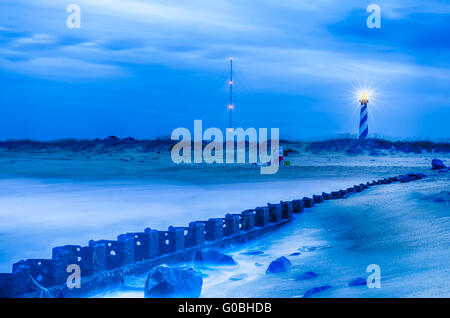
[{"left": 0, "top": 178, "right": 365, "bottom": 272}]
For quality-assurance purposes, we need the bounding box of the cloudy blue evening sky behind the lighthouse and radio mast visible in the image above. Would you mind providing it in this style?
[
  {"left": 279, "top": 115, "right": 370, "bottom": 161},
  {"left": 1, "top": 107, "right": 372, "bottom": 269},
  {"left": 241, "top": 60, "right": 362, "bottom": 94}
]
[{"left": 0, "top": 0, "right": 450, "bottom": 140}]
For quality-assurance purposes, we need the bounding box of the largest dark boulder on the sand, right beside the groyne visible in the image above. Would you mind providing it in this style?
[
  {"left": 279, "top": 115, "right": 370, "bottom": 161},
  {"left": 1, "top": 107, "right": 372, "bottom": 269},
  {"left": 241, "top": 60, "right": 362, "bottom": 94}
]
[{"left": 144, "top": 265, "right": 203, "bottom": 298}]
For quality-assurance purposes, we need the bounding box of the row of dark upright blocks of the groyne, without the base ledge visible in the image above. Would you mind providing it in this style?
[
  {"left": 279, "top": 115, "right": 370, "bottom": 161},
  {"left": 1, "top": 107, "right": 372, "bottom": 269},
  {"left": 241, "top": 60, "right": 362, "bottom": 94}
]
[{"left": 0, "top": 177, "right": 398, "bottom": 297}]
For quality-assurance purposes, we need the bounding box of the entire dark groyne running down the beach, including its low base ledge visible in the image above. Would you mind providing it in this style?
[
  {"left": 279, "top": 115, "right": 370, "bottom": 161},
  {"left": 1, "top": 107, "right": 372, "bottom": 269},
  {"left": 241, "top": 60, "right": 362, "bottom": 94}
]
[{"left": 0, "top": 176, "right": 412, "bottom": 297}]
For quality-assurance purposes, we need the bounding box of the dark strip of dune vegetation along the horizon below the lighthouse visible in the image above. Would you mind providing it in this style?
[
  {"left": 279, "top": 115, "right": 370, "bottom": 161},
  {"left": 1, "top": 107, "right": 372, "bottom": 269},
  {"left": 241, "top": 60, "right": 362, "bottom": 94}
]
[{"left": 0, "top": 136, "right": 450, "bottom": 156}]
